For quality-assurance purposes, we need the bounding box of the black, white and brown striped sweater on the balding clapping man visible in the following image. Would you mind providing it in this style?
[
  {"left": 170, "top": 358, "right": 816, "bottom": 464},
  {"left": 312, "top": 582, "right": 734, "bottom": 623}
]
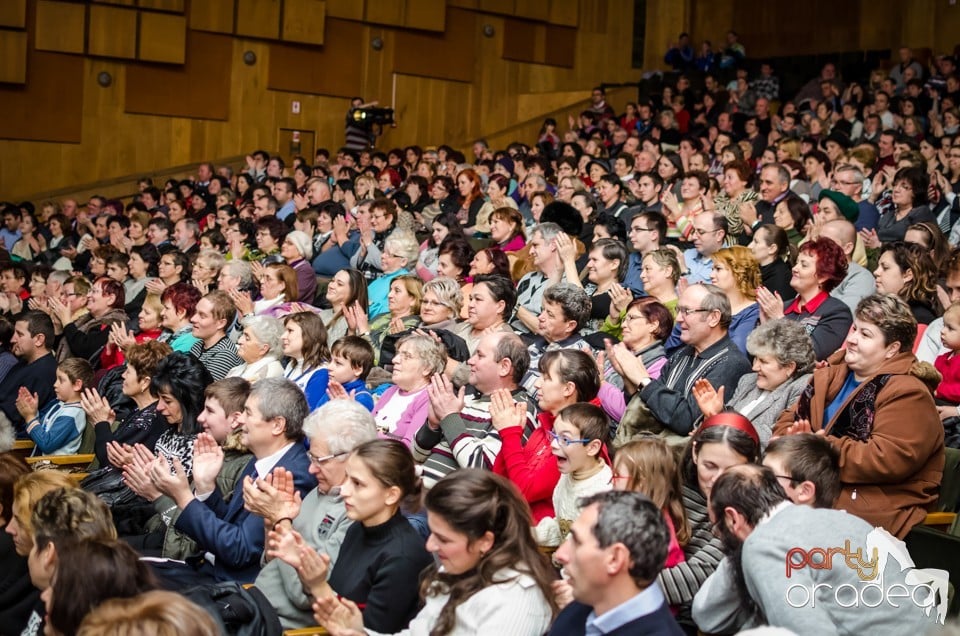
[{"left": 411, "top": 389, "right": 539, "bottom": 488}]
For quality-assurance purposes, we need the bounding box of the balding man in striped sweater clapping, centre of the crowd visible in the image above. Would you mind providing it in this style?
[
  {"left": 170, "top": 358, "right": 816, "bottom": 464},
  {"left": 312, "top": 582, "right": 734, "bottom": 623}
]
[{"left": 411, "top": 332, "right": 538, "bottom": 488}]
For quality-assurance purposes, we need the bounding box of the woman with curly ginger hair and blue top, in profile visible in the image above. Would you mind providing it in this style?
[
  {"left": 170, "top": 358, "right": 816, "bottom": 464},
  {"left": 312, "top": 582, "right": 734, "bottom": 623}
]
[{"left": 710, "top": 245, "right": 761, "bottom": 353}]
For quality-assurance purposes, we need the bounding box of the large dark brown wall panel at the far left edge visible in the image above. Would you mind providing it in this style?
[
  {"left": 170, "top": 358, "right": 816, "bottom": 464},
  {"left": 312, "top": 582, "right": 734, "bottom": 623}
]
[{"left": 0, "top": 49, "right": 84, "bottom": 141}]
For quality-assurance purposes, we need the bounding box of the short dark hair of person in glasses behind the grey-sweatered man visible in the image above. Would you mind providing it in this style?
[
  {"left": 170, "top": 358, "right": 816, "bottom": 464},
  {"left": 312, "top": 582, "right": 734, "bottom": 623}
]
[{"left": 764, "top": 433, "right": 840, "bottom": 508}]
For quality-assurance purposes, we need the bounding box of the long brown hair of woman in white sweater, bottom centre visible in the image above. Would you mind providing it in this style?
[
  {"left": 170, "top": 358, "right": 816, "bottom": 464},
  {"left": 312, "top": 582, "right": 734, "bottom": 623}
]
[{"left": 420, "top": 468, "right": 557, "bottom": 636}]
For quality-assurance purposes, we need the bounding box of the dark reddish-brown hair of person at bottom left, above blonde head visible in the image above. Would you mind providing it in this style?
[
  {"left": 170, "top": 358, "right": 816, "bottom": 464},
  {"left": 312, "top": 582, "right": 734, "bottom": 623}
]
[{"left": 47, "top": 540, "right": 158, "bottom": 636}]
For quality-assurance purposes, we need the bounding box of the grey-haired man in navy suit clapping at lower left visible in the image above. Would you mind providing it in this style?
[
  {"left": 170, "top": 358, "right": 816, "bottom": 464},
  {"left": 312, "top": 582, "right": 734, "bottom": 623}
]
[{"left": 151, "top": 378, "right": 316, "bottom": 583}]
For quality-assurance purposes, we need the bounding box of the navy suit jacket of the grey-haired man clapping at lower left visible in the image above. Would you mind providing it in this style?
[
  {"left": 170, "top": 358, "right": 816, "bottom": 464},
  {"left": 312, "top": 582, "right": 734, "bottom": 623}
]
[{"left": 174, "top": 442, "right": 317, "bottom": 583}]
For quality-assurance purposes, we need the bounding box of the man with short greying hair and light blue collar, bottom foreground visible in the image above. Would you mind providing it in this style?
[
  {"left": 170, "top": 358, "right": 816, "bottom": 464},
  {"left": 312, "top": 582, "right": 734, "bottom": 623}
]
[{"left": 550, "top": 491, "right": 683, "bottom": 636}]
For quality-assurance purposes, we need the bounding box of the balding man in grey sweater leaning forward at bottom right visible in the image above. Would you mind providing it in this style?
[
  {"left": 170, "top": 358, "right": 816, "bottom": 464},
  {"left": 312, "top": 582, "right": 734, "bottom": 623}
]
[{"left": 698, "top": 465, "right": 947, "bottom": 634}]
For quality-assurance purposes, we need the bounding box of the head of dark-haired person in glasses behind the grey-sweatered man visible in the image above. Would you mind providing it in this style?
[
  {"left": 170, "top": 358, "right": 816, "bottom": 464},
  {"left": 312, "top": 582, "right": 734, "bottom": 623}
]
[{"left": 763, "top": 433, "right": 840, "bottom": 508}]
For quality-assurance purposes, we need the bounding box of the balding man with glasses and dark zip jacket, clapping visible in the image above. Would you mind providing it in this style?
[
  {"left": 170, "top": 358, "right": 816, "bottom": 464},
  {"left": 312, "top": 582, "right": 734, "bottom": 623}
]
[{"left": 607, "top": 284, "right": 750, "bottom": 436}]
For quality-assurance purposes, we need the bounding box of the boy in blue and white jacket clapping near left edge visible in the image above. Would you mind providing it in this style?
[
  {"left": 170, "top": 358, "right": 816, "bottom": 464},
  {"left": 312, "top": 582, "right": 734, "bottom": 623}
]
[{"left": 16, "top": 358, "right": 95, "bottom": 455}]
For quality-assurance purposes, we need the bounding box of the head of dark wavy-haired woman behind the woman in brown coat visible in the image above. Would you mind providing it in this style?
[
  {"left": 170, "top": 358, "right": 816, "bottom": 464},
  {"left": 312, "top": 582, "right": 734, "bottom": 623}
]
[{"left": 873, "top": 241, "right": 942, "bottom": 325}]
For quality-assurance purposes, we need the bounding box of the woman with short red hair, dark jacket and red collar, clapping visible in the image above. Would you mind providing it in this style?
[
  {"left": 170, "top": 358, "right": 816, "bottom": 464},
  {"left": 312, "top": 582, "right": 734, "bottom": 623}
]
[{"left": 757, "top": 237, "right": 852, "bottom": 360}]
